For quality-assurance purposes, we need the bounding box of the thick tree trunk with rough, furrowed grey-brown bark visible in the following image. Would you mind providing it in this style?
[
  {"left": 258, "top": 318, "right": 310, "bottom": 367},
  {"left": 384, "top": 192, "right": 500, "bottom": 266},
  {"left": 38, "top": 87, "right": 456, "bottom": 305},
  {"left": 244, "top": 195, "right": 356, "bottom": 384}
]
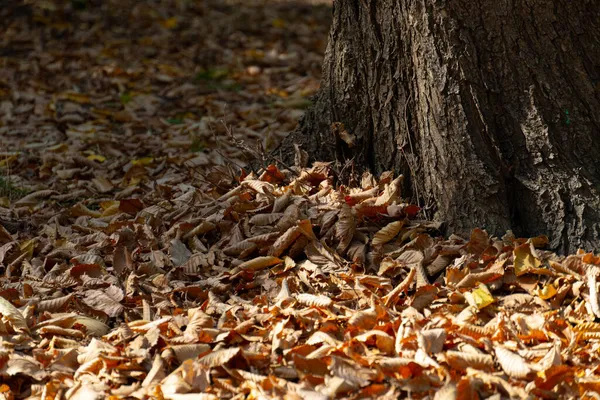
[{"left": 282, "top": 0, "right": 600, "bottom": 252}]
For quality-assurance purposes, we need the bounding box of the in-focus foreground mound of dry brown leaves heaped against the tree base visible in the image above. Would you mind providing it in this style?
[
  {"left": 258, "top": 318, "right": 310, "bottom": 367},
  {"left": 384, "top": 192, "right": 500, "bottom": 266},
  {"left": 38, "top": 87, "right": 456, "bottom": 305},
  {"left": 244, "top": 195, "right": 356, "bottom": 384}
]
[{"left": 0, "top": 158, "right": 600, "bottom": 399}]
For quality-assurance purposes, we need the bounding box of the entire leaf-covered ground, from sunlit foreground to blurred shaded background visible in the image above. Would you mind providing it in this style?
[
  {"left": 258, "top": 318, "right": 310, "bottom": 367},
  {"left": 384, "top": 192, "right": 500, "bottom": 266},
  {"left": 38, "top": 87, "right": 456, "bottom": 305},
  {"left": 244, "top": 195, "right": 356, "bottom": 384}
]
[{"left": 0, "top": 0, "right": 600, "bottom": 400}]
